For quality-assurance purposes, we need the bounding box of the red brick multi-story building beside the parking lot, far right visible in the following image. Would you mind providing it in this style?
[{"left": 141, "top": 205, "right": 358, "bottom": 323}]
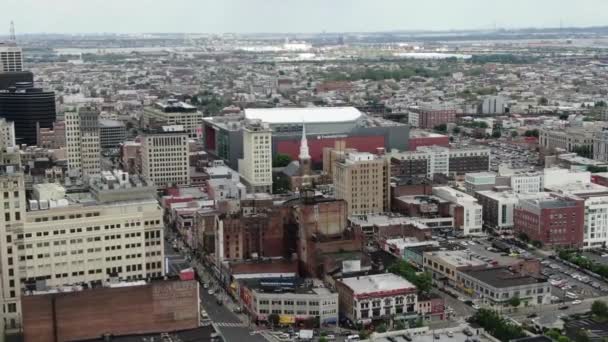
[{"left": 513, "top": 195, "right": 585, "bottom": 247}]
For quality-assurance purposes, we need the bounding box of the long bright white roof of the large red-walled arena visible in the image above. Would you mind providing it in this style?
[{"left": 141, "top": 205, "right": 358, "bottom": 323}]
[{"left": 245, "top": 107, "right": 363, "bottom": 124}]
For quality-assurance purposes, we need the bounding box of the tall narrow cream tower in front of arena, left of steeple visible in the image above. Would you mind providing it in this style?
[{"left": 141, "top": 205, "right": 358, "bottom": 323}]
[{"left": 238, "top": 120, "right": 272, "bottom": 193}]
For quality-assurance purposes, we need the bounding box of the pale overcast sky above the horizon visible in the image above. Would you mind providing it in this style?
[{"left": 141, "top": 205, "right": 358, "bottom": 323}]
[{"left": 0, "top": 0, "right": 608, "bottom": 34}]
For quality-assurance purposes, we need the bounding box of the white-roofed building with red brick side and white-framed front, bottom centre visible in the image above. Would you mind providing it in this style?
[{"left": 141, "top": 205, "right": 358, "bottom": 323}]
[{"left": 336, "top": 273, "right": 418, "bottom": 324}]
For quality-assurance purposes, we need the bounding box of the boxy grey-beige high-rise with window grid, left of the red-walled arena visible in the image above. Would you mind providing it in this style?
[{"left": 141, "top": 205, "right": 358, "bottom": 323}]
[{"left": 141, "top": 126, "right": 190, "bottom": 187}]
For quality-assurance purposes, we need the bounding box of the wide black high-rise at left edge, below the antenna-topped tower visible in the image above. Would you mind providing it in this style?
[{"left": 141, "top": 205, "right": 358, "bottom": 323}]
[{"left": 0, "top": 83, "right": 56, "bottom": 145}]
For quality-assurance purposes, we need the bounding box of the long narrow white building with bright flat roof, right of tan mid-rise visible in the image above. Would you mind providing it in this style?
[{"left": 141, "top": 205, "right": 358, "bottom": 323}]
[{"left": 433, "top": 186, "right": 483, "bottom": 236}]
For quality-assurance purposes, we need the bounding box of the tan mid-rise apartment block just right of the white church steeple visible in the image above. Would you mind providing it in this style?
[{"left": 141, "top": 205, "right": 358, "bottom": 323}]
[{"left": 332, "top": 152, "right": 390, "bottom": 215}]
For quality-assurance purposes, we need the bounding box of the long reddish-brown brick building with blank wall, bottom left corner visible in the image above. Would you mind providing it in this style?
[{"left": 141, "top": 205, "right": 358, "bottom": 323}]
[{"left": 22, "top": 280, "right": 199, "bottom": 342}]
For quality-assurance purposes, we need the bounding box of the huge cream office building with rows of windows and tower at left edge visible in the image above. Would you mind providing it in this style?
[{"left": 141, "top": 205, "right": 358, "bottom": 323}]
[{"left": 0, "top": 171, "right": 164, "bottom": 331}]
